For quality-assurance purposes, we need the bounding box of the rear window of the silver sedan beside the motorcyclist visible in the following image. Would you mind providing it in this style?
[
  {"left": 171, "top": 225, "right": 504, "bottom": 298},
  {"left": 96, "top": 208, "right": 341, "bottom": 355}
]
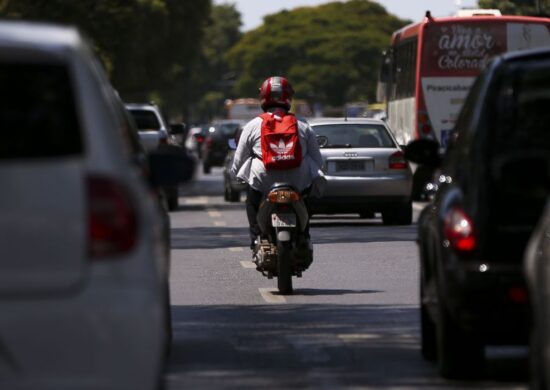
[{"left": 313, "top": 123, "right": 395, "bottom": 148}]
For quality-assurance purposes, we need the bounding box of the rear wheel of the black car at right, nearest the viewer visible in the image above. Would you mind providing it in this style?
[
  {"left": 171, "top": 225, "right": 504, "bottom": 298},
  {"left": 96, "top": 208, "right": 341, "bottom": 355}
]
[{"left": 436, "top": 296, "right": 485, "bottom": 379}]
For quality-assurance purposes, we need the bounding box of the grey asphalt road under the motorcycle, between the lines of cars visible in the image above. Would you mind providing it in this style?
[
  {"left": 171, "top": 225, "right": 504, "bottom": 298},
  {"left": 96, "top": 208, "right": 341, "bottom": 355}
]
[{"left": 166, "top": 168, "right": 527, "bottom": 390}]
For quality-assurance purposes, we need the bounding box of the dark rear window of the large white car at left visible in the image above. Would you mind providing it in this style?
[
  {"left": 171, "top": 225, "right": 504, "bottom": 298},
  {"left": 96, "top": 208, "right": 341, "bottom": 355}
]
[{"left": 0, "top": 63, "right": 83, "bottom": 160}]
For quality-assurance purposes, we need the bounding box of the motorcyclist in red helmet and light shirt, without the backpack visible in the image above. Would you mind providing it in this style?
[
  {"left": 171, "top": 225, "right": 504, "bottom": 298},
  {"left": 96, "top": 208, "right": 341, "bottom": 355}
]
[{"left": 231, "top": 76, "right": 325, "bottom": 249}]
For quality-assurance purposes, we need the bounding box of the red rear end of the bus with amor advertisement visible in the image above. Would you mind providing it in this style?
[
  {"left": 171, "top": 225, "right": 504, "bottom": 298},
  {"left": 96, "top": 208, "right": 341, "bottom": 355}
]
[{"left": 418, "top": 16, "right": 550, "bottom": 149}]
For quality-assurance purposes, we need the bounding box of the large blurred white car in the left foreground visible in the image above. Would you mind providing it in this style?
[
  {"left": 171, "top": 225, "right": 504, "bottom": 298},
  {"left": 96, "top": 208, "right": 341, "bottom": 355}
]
[{"left": 0, "top": 22, "right": 191, "bottom": 390}]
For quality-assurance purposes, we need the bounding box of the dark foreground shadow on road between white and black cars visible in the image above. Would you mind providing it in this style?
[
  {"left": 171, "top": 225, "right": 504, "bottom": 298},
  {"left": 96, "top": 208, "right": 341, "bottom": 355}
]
[{"left": 167, "top": 305, "right": 526, "bottom": 389}]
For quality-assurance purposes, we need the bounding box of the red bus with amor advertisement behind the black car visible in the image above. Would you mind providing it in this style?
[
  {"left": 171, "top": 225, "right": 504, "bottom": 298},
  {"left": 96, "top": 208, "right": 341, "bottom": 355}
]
[{"left": 378, "top": 10, "right": 550, "bottom": 197}]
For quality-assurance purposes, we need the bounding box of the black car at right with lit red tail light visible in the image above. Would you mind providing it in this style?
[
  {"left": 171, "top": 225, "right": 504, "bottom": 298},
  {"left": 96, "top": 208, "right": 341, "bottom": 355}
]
[{"left": 406, "top": 49, "right": 550, "bottom": 378}]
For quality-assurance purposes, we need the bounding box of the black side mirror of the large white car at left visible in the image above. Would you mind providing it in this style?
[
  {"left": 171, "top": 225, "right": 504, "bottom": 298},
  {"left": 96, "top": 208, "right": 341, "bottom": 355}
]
[{"left": 148, "top": 144, "right": 195, "bottom": 187}]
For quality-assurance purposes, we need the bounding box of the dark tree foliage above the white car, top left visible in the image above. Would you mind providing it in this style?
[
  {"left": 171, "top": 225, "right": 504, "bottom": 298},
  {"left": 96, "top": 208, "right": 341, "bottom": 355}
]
[{"left": 0, "top": 0, "right": 211, "bottom": 116}]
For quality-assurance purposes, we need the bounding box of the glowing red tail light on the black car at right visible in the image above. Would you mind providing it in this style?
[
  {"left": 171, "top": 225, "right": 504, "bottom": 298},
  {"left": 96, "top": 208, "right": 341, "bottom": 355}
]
[{"left": 444, "top": 208, "right": 477, "bottom": 253}]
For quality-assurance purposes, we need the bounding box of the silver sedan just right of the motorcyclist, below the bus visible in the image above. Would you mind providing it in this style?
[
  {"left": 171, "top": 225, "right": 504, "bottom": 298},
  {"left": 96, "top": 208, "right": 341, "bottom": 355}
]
[{"left": 310, "top": 118, "right": 412, "bottom": 225}]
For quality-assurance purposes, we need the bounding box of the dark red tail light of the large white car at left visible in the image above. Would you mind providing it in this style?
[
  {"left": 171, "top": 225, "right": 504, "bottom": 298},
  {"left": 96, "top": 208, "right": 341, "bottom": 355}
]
[{"left": 88, "top": 176, "right": 137, "bottom": 259}]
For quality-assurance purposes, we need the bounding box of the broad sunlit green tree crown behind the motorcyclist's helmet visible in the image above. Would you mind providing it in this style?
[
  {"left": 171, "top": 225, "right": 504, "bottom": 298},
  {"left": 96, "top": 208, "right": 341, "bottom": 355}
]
[{"left": 228, "top": 0, "right": 405, "bottom": 105}]
